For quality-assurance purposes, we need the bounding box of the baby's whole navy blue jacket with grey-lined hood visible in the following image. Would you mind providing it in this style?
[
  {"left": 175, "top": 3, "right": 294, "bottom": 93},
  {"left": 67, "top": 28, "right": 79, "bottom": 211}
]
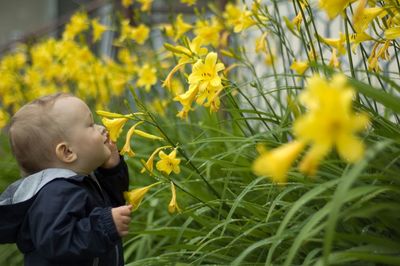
[{"left": 0, "top": 158, "right": 129, "bottom": 266}]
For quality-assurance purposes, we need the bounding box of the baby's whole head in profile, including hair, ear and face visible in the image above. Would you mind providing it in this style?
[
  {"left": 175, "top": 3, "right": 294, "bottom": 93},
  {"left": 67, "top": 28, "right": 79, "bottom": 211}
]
[{"left": 9, "top": 93, "right": 111, "bottom": 177}]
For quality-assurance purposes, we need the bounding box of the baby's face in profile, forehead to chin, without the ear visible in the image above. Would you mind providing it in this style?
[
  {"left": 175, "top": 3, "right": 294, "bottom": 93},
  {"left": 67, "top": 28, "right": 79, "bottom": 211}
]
[{"left": 52, "top": 97, "right": 111, "bottom": 173}]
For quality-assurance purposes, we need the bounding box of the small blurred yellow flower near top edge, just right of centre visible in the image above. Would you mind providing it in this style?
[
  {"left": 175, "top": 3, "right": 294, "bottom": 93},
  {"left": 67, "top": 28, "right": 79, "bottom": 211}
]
[{"left": 223, "top": 3, "right": 256, "bottom": 32}]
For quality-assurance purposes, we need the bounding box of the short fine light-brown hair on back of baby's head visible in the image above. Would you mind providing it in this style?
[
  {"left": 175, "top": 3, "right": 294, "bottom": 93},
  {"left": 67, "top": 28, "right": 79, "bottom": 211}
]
[{"left": 8, "top": 93, "right": 72, "bottom": 174}]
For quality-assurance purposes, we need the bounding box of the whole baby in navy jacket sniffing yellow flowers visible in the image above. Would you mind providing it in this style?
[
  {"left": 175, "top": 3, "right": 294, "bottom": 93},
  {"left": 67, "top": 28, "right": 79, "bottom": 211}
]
[{"left": 0, "top": 93, "right": 132, "bottom": 266}]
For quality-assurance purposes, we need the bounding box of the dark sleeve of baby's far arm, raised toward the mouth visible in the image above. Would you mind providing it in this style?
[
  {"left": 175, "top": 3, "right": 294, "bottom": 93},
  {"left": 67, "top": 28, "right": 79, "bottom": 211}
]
[{"left": 95, "top": 156, "right": 129, "bottom": 207}]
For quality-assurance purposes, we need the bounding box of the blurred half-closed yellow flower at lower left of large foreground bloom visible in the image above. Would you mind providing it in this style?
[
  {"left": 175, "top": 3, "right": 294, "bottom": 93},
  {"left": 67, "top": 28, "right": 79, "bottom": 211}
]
[{"left": 252, "top": 141, "right": 304, "bottom": 184}]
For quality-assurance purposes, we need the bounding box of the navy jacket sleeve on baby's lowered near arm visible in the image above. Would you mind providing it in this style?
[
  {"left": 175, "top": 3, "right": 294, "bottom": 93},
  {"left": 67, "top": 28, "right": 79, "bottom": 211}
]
[{"left": 28, "top": 180, "right": 120, "bottom": 259}]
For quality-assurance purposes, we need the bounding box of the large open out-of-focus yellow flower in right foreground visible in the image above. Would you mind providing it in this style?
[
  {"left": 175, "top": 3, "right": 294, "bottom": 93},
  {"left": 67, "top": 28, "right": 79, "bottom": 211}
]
[{"left": 293, "top": 74, "right": 368, "bottom": 175}]
